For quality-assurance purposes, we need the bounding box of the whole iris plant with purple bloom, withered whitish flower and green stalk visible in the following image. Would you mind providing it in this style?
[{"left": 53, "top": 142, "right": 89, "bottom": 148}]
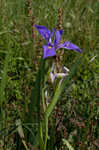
[{"left": 34, "top": 25, "right": 82, "bottom": 150}]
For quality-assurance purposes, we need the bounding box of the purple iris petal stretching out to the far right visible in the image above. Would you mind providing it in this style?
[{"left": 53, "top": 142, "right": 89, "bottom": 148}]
[{"left": 57, "top": 41, "right": 82, "bottom": 53}]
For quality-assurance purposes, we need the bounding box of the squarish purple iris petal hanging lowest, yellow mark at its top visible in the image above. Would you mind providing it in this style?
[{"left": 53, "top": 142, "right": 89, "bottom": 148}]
[{"left": 43, "top": 45, "right": 56, "bottom": 59}]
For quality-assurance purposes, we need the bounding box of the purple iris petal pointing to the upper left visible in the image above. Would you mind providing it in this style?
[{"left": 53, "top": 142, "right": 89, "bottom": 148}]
[{"left": 34, "top": 25, "right": 52, "bottom": 42}]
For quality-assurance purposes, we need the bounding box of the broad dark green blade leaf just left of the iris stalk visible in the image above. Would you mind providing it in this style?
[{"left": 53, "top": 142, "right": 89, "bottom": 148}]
[{"left": 27, "top": 59, "right": 44, "bottom": 147}]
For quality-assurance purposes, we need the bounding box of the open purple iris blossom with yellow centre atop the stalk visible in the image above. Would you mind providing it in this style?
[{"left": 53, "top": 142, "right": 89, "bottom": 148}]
[{"left": 34, "top": 25, "right": 82, "bottom": 59}]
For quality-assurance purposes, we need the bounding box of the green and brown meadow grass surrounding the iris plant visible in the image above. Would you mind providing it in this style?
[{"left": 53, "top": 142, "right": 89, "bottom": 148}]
[{"left": 0, "top": 0, "right": 99, "bottom": 150}]
